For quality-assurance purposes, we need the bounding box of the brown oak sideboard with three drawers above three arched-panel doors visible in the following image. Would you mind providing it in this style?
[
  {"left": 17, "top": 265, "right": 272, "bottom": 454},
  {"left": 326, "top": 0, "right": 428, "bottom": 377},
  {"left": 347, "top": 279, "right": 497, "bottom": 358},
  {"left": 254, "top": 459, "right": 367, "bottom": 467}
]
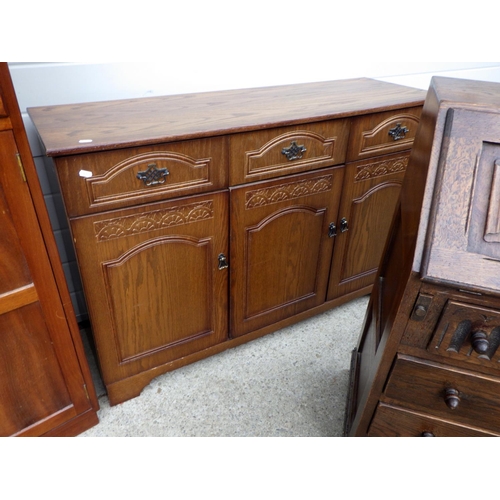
[{"left": 28, "top": 79, "right": 425, "bottom": 404}]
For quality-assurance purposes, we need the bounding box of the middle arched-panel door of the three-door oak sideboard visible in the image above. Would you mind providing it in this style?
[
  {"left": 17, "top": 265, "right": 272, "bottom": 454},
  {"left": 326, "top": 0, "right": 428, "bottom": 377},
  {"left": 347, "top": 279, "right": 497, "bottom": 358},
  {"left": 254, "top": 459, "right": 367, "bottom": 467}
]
[{"left": 230, "top": 167, "right": 343, "bottom": 337}]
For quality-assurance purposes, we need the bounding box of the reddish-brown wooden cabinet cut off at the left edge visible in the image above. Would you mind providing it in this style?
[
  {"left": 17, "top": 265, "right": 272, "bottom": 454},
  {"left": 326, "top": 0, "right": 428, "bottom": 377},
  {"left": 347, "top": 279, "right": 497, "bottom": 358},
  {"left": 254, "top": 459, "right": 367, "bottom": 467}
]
[{"left": 0, "top": 63, "right": 99, "bottom": 437}]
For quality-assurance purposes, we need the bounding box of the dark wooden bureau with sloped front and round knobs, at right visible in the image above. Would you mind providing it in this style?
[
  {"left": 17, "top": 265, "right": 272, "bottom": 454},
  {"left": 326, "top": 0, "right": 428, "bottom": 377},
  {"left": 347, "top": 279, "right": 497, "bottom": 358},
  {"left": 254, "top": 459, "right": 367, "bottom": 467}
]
[{"left": 346, "top": 77, "right": 500, "bottom": 437}]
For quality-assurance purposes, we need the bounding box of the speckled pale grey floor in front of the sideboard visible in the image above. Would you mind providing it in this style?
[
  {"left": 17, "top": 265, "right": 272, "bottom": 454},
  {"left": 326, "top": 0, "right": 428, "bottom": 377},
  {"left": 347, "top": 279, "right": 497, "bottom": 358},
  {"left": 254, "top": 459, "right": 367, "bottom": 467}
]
[{"left": 80, "top": 297, "right": 368, "bottom": 437}]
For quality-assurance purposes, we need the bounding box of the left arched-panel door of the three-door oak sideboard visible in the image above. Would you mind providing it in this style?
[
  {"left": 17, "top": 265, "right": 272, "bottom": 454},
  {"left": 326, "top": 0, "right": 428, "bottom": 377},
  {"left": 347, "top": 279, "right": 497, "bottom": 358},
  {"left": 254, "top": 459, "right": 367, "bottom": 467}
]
[{"left": 71, "top": 192, "right": 228, "bottom": 385}]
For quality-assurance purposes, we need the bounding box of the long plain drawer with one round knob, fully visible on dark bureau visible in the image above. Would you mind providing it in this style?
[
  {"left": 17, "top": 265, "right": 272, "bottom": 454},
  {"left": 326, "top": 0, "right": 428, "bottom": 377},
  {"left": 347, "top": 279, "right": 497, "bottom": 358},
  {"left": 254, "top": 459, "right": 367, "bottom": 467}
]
[{"left": 383, "top": 356, "right": 500, "bottom": 432}]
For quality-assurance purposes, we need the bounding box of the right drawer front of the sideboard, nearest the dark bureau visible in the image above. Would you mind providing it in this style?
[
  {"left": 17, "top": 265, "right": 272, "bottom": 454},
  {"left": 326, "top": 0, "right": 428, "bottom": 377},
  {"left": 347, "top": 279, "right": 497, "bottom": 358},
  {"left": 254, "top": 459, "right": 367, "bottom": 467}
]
[{"left": 347, "top": 107, "right": 422, "bottom": 161}]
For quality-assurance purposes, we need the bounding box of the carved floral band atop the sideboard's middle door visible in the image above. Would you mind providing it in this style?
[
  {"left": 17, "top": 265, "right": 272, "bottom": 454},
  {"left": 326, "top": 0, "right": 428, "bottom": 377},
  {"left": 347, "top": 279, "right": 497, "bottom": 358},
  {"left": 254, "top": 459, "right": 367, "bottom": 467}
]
[{"left": 245, "top": 175, "right": 333, "bottom": 210}]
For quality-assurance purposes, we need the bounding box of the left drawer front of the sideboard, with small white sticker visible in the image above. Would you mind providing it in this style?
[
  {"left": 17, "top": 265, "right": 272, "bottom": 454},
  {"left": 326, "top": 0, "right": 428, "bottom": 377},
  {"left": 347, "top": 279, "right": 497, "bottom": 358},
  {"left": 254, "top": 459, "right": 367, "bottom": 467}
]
[{"left": 56, "top": 138, "right": 227, "bottom": 217}]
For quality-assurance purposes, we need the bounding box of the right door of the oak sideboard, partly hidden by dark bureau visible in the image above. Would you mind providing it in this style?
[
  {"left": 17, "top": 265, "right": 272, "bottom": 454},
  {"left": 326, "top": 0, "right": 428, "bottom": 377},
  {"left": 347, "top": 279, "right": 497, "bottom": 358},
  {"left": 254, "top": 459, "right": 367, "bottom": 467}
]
[{"left": 328, "top": 153, "right": 409, "bottom": 300}]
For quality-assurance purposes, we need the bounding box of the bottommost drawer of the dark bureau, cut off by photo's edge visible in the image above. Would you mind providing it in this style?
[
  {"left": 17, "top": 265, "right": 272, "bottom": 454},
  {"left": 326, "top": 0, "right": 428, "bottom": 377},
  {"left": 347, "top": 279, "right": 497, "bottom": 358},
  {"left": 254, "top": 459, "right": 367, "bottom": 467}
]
[{"left": 368, "top": 403, "right": 496, "bottom": 437}]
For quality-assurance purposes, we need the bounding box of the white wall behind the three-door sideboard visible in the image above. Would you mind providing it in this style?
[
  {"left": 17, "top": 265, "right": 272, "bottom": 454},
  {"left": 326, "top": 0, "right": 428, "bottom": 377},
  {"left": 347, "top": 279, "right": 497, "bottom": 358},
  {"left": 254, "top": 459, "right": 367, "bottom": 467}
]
[{"left": 9, "top": 61, "right": 500, "bottom": 320}]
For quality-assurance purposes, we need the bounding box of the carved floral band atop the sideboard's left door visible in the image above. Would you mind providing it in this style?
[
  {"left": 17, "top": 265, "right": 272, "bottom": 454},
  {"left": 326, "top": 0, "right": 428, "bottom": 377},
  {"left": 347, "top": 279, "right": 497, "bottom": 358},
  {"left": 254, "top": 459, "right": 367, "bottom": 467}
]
[{"left": 94, "top": 201, "right": 213, "bottom": 241}]
